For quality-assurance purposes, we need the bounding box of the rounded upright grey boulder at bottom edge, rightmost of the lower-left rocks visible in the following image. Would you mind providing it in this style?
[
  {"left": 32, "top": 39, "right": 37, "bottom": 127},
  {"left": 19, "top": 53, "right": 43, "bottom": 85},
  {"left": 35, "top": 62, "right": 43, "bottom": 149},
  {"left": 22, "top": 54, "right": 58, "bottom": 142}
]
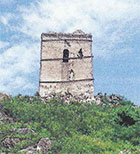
[{"left": 37, "top": 138, "right": 52, "bottom": 154}]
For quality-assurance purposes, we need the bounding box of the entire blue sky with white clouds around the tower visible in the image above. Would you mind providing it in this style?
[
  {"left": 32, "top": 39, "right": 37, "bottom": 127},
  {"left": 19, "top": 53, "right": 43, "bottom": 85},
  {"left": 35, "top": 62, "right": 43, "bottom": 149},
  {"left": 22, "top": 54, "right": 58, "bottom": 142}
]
[{"left": 0, "top": 0, "right": 140, "bottom": 105}]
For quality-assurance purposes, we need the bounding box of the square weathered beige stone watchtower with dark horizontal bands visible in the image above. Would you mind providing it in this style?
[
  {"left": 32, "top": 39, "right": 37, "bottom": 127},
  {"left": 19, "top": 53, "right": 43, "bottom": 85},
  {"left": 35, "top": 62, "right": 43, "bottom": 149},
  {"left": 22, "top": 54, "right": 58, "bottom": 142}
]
[{"left": 39, "top": 30, "right": 94, "bottom": 100}]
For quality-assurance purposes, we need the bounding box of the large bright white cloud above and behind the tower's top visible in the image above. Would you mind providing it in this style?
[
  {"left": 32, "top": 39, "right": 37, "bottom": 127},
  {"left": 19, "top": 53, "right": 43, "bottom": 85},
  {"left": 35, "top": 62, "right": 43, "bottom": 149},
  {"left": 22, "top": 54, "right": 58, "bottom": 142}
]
[{"left": 15, "top": 0, "right": 140, "bottom": 57}]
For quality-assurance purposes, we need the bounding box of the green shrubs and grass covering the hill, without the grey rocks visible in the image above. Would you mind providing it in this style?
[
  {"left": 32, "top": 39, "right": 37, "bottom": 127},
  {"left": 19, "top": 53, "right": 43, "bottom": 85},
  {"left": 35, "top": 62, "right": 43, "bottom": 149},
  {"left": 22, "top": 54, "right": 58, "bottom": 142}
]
[{"left": 0, "top": 96, "right": 140, "bottom": 154}]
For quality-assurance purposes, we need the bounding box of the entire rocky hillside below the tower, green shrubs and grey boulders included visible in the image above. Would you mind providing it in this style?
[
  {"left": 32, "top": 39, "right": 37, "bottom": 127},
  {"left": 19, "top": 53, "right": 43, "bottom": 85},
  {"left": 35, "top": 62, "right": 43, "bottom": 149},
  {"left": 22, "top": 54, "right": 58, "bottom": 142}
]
[{"left": 0, "top": 93, "right": 140, "bottom": 154}]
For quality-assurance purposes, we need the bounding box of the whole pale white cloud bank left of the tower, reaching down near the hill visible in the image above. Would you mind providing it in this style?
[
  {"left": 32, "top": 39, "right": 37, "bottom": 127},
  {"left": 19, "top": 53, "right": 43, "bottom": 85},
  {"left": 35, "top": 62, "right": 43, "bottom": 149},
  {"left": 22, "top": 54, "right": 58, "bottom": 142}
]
[{"left": 0, "top": 42, "right": 40, "bottom": 93}]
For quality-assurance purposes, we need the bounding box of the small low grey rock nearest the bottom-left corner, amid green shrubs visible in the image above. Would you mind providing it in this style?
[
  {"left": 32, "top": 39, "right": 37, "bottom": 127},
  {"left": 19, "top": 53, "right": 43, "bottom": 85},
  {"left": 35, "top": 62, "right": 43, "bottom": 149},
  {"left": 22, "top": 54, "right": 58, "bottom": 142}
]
[{"left": 2, "top": 138, "right": 20, "bottom": 149}]
